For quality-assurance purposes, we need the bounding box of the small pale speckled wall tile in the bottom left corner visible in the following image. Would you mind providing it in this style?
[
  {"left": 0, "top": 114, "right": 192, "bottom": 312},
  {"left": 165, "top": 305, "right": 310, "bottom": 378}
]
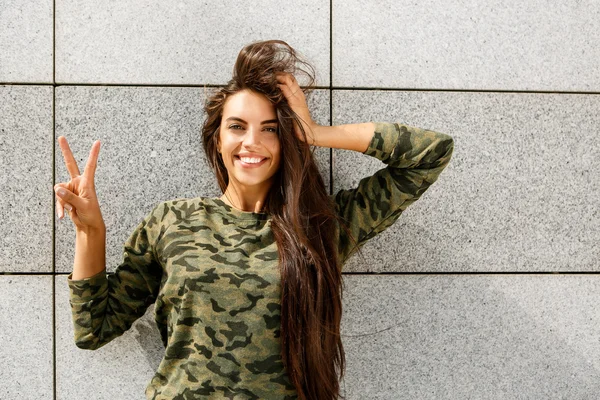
[{"left": 0, "top": 275, "right": 53, "bottom": 400}]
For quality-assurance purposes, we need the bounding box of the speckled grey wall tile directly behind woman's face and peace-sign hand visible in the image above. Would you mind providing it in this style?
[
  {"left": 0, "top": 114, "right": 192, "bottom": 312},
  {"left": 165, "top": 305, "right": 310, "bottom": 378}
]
[{"left": 51, "top": 86, "right": 330, "bottom": 272}]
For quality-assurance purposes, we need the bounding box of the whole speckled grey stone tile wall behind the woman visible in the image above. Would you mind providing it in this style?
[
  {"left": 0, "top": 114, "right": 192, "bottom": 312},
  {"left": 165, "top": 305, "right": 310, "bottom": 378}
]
[{"left": 0, "top": 0, "right": 600, "bottom": 400}]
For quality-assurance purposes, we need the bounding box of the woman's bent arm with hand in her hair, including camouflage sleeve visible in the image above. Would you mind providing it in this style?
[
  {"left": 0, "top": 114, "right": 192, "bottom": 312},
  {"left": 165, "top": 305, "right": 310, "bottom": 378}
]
[{"left": 277, "top": 74, "right": 454, "bottom": 264}]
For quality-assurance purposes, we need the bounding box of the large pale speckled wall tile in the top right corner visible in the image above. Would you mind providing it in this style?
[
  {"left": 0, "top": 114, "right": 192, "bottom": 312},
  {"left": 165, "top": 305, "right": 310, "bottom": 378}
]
[{"left": 332, "top": 0, "right": 600, "bottom": 92}]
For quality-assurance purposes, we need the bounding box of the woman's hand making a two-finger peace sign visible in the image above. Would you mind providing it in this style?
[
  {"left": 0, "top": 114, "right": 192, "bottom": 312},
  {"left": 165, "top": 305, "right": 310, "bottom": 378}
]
[{"left": 54, "top": 136, "right": 106, "bottom": 233}]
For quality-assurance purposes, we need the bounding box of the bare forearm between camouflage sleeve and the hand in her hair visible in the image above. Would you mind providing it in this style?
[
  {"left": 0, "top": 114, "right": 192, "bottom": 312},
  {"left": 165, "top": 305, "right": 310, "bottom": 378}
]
[{"left": 307, "top": 122, "right": 375, "bottom": 153}]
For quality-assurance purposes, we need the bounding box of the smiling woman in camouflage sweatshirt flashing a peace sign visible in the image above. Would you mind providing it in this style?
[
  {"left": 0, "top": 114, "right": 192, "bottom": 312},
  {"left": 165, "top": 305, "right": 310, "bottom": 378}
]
[{"left": 55, "top": 40, "right": 454, "bottom": 400}]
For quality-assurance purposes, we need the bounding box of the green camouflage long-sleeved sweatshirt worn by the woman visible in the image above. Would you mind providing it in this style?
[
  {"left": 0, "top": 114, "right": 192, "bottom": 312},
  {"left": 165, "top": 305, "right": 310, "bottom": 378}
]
[{"left": 68, "top": 123, "right": 454, "bottom": 400}]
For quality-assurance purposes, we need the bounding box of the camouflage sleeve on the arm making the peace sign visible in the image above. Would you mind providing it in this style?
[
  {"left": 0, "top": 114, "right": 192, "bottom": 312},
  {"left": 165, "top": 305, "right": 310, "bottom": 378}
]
[{"left": 67, "top": 203, "right": 167, "bottom": 350}]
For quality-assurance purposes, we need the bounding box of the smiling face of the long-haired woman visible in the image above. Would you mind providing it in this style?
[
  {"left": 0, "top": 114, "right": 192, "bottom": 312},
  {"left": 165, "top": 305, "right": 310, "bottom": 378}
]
[{"left": 217, "top": 90, "right": 280, "bottom": 197}]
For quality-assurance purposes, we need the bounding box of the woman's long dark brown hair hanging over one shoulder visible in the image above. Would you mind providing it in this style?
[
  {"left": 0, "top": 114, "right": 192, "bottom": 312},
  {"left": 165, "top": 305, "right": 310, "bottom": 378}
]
[{"left": 202, "top": 40, "right": 345, "bottom": 400}]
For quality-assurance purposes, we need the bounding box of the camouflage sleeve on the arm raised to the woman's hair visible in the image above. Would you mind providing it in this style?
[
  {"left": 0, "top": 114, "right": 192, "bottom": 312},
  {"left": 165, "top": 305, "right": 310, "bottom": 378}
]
[{"left": 332, "top": 122, "right": 454, "bottom": 264}]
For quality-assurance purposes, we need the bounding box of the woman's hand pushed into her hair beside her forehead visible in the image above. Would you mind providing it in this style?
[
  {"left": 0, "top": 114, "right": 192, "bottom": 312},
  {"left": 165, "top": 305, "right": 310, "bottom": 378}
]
[{"left": 277, "top": 73, "right": 318, "bottom": 145}]
